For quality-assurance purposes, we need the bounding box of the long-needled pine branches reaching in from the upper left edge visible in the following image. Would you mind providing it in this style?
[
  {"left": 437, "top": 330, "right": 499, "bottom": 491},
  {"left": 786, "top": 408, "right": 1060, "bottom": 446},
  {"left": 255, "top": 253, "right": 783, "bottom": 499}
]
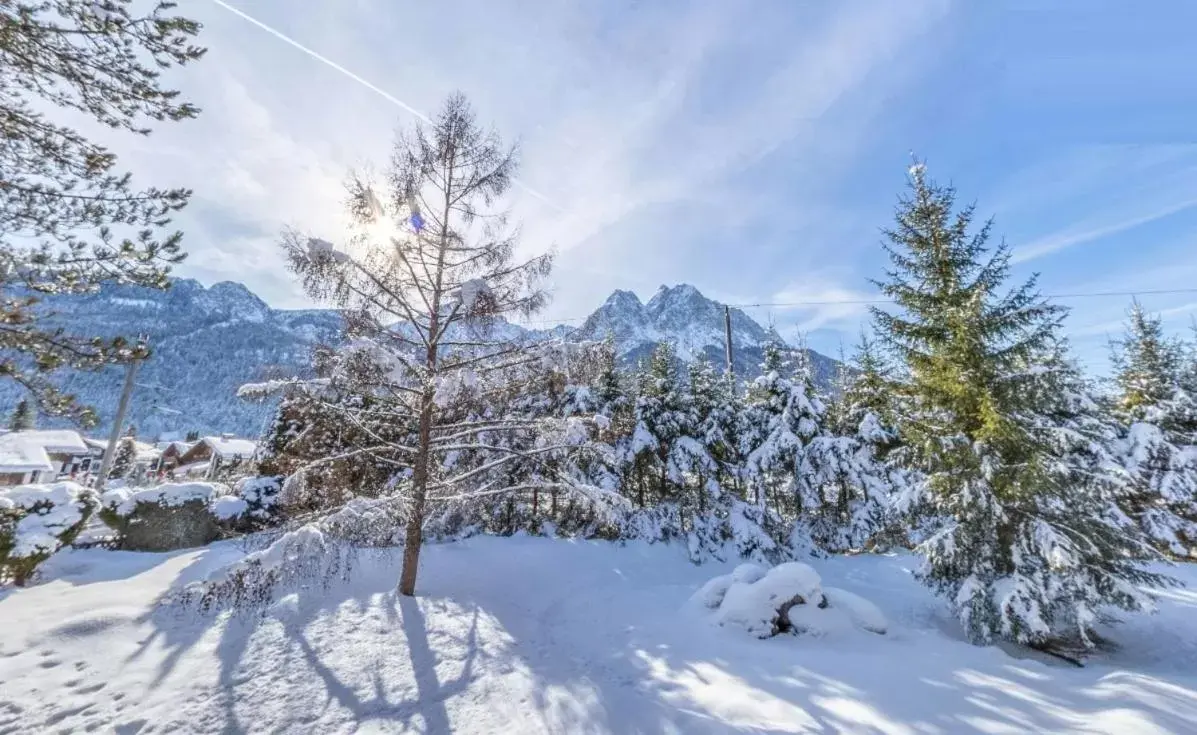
[{"left": 0, "top": 0, "right": 203, "bottom": 426}]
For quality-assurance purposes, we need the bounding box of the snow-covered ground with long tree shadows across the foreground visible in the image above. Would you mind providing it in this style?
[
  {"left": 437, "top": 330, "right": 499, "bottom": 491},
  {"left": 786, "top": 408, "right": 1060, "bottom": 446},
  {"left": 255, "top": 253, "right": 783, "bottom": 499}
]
[{"left": 0, "top": 537, "right": 1197, "bottom": 735}]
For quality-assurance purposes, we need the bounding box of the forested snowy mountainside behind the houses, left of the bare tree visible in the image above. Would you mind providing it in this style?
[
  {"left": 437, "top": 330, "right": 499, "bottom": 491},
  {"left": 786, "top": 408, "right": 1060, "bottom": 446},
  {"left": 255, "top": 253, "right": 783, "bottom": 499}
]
[{"left": 0, "top": 279, "right": 341, "bottom": 438}]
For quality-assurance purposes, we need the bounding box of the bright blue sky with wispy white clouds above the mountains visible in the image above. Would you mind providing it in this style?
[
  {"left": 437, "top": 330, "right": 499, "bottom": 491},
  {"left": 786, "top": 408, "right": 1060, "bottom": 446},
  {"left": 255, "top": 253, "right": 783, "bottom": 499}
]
[{"left": 113, "top": 0, "right": 1197, "bottom": 371}]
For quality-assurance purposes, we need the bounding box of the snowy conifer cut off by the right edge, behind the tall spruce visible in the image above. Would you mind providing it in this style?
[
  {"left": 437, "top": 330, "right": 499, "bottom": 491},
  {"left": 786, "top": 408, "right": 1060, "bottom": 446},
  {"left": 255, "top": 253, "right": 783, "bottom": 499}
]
[{"left": 1111, "top": 303, "right": 1197, "bottom": 555}]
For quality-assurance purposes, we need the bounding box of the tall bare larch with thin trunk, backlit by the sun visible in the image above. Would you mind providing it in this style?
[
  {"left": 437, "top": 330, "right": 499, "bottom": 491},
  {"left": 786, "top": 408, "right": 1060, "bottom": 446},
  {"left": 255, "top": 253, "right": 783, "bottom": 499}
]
[{"left": 284, "top": 95, "right": 608, "bottom": 595}]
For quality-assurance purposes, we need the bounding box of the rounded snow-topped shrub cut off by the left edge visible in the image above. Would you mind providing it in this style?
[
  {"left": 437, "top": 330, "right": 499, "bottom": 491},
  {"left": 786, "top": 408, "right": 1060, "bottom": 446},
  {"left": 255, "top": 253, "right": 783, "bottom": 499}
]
[{"left": 0, "top": 482, "right": 98, "bottom": 584}]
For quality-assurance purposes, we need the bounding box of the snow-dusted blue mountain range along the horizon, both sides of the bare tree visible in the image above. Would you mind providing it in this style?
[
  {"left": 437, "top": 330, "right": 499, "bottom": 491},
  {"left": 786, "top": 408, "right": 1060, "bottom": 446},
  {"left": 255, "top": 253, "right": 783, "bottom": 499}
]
[{"left": 0, "top": 279, "right": 837, "bottom": 438}]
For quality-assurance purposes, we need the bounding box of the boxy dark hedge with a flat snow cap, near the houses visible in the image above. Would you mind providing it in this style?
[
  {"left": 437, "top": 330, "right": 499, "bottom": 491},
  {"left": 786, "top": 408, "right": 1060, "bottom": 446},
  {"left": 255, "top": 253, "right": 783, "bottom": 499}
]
[{"left": 101, "top": 482, "right": 235, "bottom": 551}]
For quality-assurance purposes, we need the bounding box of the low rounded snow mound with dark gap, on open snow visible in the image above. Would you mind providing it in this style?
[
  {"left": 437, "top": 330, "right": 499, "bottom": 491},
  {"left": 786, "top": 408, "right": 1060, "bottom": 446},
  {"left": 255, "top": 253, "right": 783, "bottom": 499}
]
[{"left": 691, "top": 561, "right": 888, "bottom": 638}]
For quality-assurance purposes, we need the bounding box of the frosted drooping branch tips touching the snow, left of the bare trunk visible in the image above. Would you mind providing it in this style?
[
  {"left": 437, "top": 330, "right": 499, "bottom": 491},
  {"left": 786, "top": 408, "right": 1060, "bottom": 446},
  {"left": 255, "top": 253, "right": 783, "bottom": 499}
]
[{"left": 169, "top": 524, "right": 353, "bottom": 612}]
